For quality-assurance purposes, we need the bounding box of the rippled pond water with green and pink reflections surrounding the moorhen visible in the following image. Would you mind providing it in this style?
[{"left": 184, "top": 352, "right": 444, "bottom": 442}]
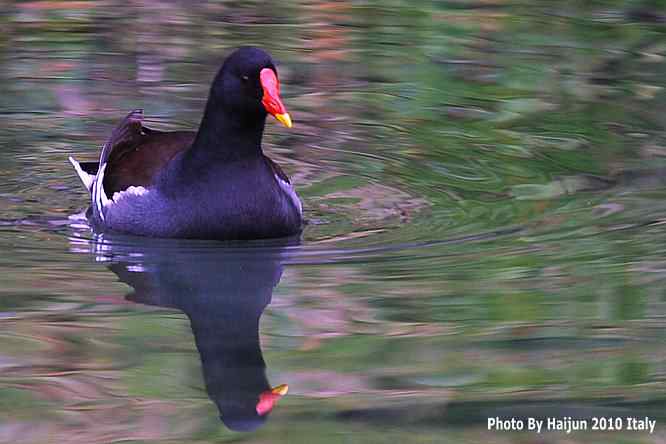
[{"left": 0, "top": 0, "right": 666, "bottom": 443}]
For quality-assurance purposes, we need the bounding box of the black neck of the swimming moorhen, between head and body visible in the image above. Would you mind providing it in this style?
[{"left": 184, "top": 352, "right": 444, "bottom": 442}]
[{"left": 186, "top": 101, "right": 266, "bottom": 164}]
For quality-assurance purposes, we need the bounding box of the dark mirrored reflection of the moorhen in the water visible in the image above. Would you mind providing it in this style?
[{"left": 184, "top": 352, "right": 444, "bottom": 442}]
[{"left": 80, "top": 237, "right": 298, "bottom": 431}]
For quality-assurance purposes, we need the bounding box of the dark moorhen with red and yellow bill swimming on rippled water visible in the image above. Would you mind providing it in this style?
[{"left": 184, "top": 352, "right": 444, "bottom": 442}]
[{"left": 70, "top": 47, "right": 302, "bottom": 239}]
